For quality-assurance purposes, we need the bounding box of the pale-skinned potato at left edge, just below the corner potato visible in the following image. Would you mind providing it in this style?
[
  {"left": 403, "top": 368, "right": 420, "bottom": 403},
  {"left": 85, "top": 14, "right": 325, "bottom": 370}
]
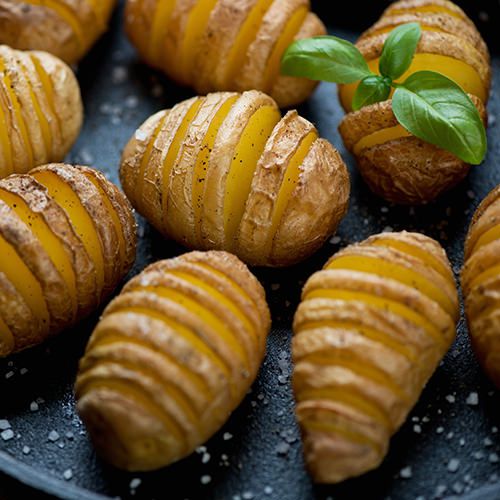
[{"left": 0, "top": 45, "right": 83, "bottom": 178}]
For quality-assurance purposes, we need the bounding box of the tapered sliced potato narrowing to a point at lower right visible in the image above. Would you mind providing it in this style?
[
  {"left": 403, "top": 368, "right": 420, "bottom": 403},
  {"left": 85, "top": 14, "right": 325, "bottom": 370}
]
[{"left": 292, "top": 232, "right": 459, "bottom": 483}]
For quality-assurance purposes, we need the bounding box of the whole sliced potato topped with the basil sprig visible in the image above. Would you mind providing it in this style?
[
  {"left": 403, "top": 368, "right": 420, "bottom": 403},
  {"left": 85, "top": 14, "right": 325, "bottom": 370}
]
[{"left": 339, "top": 0, "right": 491, "bottom": 204}]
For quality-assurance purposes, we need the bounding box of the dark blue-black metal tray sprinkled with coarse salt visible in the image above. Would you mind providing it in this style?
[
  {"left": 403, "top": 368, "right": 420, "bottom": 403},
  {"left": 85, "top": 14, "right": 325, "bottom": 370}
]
[{"left": 0, "top": 0, "right": 500, "bottom": 500}]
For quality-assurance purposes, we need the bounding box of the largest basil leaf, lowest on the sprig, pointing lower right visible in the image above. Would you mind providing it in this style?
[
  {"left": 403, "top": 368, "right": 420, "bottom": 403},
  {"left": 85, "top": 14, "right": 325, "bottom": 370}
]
[{"left": 392, "top": 71, "right": 487, "bottom": 165}]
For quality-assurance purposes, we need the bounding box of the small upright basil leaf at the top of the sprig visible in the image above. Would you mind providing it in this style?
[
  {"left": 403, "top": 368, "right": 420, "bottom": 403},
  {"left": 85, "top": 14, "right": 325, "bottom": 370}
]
[{"left": 379, "top": 23, "right": 422, "bottom": 80}]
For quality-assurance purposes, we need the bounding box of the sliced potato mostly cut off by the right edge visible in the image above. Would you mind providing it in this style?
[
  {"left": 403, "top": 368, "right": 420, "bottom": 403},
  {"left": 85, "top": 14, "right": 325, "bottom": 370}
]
[{"left": 462, "top": 186, "right": 500, "bottom": 387}]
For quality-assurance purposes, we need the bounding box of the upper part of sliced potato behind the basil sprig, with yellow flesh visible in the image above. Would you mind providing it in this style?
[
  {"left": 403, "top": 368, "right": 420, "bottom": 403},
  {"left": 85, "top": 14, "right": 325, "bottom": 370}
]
[{"left": 339, "top": 0, "right": 491, "bottom": 112}]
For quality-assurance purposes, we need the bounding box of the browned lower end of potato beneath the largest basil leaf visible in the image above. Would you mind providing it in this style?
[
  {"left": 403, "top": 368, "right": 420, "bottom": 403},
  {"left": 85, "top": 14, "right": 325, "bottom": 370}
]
[{"left": 339, "top": 95, "right": 487, "bottom": 205}]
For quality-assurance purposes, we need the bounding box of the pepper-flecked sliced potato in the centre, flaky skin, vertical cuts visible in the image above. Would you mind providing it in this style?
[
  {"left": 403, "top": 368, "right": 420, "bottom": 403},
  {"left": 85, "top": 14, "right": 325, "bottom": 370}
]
[{"left": 120, "top": 91, "right": 349, "bottom": 266}]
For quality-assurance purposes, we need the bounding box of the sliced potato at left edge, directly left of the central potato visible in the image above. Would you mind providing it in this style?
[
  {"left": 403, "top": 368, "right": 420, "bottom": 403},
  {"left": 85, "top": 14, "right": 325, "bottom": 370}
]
[{"left": 0, "top": 164, "right": 136, "bottom": 356}]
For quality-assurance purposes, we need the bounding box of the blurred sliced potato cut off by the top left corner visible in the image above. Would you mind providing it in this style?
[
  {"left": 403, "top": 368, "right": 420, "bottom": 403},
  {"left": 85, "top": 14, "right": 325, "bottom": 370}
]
[{"left": 0, "top": 0, "right": 117, "bottom": 64}]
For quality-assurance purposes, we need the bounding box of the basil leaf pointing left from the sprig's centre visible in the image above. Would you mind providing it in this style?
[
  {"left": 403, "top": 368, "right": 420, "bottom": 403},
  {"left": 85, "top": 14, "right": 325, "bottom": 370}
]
[{"left": 281, "top": 36, "right": 372, "bottom": 83}]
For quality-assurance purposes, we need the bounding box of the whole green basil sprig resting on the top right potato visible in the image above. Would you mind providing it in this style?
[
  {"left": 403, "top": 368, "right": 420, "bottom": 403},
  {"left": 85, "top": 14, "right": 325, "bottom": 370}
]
[{"left": 281, "top": 23, "right": 487, "bottom": 165}]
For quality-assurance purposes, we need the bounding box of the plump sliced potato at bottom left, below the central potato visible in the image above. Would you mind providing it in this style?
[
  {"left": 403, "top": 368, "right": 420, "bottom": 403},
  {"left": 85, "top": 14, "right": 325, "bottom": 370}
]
[{"left": 76, "top": 251, "right": 270, "bottom": 471}]
